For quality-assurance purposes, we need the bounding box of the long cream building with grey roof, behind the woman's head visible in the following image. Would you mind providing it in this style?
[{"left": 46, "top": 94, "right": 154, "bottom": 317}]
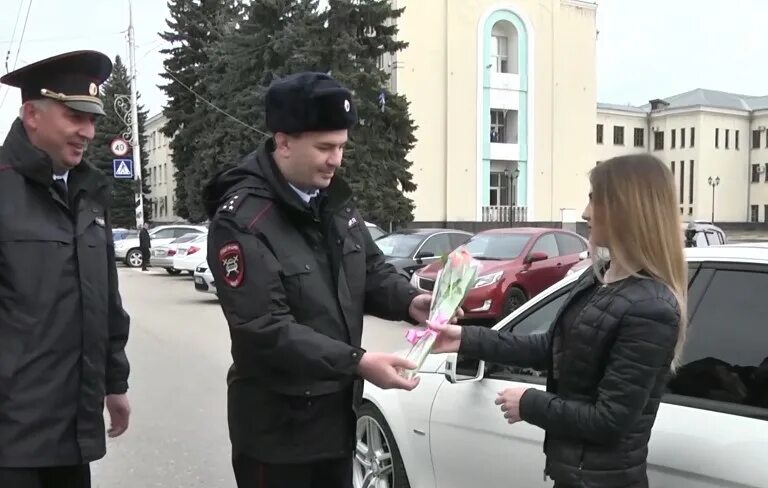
[{"left": 596, "top": 89, "right": 768, "bottom": 222}]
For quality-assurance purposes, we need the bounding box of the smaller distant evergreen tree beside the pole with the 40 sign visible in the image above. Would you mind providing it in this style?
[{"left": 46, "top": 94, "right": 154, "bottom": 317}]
[{"left": 88, "top": 56, "right": 152, "bottom": 228}]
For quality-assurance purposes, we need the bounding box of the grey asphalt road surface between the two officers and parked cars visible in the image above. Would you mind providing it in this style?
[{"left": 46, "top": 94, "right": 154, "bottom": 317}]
[{"left": 92, "top": 268, "right": 414, "bottom": 488}]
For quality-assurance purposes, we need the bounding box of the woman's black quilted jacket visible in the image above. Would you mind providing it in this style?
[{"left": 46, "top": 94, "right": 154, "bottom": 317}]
[{"left": 460, "top": 271, "right": 680, "bottom": 488}]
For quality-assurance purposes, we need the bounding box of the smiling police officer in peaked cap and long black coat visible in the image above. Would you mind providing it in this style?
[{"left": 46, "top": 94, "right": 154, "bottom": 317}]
[{"left": 0, "top": 51, "right": 129, "bottom": 488}]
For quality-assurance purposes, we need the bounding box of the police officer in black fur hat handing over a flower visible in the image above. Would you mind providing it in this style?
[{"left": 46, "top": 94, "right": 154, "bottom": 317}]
[{"left": 205, "top": 73, "right": 430, "bottom": 488}]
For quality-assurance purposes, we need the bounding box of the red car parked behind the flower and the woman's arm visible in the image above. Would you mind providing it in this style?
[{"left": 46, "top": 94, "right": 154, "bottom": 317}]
[{"left": 411, "top": 228, "right": 587, "bottom": 320}]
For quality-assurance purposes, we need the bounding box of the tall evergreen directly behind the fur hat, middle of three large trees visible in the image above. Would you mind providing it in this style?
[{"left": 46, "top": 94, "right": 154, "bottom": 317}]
[{"left": 187, "top": 0, "right": 323, "bottom": 221}]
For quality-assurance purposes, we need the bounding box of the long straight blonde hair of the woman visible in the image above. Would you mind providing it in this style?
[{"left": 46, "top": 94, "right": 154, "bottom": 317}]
[{"left": 590, "top": 154, "right": 688, "bottom": 371}]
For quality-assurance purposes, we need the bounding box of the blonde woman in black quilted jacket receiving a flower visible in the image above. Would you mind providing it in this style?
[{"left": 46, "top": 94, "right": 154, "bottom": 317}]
[{"left": 433, "top": 154, "right": 687, "bottom": 488}]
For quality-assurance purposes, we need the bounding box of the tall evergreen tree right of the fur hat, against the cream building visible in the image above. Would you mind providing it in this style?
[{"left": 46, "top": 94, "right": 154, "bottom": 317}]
[{"left": 322, "top": 0, "right": 416, "bottom": 228}]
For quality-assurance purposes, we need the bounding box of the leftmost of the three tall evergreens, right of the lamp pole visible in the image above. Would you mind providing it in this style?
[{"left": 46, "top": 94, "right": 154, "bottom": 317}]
[{"left": 160, "top": 0, "right": 242, "bottom": 221}]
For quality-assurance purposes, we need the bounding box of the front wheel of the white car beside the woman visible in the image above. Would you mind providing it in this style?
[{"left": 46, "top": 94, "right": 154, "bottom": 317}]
[{"left": 352, "top": 403, "right": 411, "bottom": 488}]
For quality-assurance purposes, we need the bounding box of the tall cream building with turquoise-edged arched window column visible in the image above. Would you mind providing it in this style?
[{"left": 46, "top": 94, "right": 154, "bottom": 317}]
[{"left": 384, "top": 0, "right": 597, "bottom": 222}]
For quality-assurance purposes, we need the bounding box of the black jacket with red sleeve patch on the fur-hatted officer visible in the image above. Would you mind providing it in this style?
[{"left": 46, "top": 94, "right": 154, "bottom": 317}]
[{"left": 205, "top": 139, "right": 416, "bottom": 462}]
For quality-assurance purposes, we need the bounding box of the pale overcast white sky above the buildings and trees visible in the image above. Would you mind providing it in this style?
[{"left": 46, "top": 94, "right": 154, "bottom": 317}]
[{"left": 0, "top": 0, "right": 768, "bottom": 141}]
